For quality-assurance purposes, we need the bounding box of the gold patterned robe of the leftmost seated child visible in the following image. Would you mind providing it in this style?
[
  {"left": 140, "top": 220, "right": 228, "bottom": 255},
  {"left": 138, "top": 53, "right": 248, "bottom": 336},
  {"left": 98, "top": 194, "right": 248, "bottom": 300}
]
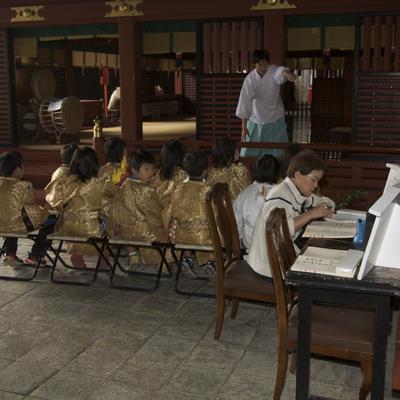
[{"left": 0, "top": 177, "right": 47, "bottom": 232}]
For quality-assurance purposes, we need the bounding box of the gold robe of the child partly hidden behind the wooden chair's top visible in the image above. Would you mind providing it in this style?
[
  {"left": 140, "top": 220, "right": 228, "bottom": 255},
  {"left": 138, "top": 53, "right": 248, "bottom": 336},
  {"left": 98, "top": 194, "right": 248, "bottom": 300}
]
[{"left": 207, "top": 163, "right": 251, "bottom": 201}]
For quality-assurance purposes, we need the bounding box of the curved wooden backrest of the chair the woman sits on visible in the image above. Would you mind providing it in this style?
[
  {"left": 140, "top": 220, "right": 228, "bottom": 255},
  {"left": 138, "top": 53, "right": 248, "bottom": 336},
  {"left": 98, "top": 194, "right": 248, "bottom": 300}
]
[{"left": 206, "top": 183, "right": 241, "bottom": 287}]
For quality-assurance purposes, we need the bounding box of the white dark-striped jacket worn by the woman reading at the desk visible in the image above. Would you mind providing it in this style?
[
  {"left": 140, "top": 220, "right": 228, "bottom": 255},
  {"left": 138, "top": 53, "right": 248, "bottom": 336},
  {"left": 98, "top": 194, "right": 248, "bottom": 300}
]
[{"left": 247, "top": 178, "right": 335, "bottom": 277}]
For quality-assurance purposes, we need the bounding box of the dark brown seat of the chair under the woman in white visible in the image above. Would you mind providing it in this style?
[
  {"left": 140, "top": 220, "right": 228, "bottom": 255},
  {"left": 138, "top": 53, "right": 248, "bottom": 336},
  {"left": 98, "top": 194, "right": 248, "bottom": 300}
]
[{"left": 223, "top": 260, "right": 275, "bottom": 303}]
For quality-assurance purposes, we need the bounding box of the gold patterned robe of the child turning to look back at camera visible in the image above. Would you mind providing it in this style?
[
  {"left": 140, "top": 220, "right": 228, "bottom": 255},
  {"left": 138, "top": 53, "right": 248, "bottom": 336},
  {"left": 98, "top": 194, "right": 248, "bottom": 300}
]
[{"left": 109, "top": 178, "right": 167, "bottom": 264}]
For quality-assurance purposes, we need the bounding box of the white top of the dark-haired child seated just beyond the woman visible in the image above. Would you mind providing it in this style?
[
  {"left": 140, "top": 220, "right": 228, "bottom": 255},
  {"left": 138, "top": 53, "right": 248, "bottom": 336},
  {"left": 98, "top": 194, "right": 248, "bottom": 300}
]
[{"left": 233, "top": 182, "right": 273, "bottom": 249}]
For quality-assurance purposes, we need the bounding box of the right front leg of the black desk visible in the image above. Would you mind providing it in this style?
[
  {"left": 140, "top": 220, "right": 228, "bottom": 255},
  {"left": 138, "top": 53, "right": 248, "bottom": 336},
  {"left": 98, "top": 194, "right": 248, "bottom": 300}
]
[{"left": 371, "top": 295, "right": 391, "bottom": 400}]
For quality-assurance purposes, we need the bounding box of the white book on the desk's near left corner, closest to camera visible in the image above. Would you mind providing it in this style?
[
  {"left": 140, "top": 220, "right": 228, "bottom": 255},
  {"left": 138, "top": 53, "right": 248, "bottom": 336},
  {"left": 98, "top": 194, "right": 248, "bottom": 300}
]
[{"left": 292, "top": 246, "right": 364, "bottom": 278}]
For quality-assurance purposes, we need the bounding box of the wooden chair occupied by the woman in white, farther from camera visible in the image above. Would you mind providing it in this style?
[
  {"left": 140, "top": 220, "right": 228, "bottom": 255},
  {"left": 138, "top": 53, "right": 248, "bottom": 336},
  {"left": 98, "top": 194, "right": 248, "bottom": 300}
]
[{"left": 206, "top": 183, "right": 275, "bottom": 339}]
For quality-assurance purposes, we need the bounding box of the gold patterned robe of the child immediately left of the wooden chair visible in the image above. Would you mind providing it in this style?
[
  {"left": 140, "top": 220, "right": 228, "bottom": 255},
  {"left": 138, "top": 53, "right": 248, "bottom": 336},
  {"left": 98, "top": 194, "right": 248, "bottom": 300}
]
[{"left": 169, "top": 179, "right": 213, "bottom": 264}]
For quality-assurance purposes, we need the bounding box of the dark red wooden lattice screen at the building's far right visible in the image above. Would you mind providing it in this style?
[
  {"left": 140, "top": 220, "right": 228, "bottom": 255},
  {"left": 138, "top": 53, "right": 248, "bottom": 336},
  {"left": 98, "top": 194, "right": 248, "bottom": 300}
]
[{"left": 353, "top": 15, "right": 400, "bottom": 147}]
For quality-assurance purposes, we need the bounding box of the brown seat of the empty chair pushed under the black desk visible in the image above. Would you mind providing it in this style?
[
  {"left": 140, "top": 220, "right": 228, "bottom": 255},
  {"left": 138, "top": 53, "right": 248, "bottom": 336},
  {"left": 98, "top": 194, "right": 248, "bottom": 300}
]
[{"left": 287, "top": 305, "right": 375, "bottom": 354}]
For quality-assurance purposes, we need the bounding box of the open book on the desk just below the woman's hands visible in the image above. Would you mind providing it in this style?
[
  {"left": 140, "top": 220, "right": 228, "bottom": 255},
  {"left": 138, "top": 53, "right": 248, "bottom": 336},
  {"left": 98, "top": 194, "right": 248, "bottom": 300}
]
[{"left": 303, "top": 219, "right": 357, "bottom": 239}]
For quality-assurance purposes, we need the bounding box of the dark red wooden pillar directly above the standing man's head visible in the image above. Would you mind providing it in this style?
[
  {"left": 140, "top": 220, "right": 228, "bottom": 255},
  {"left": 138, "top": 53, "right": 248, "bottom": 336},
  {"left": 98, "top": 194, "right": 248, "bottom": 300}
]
[{"left": 264, "top": 10, "right": 286, "bottom": 65}]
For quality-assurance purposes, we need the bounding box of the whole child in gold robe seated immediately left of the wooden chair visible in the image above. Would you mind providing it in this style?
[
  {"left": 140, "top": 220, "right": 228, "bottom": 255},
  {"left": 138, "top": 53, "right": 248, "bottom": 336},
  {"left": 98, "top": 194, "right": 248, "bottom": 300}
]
[{"left": 168, "top": 151, "right": 211, "bottom": 276}]
